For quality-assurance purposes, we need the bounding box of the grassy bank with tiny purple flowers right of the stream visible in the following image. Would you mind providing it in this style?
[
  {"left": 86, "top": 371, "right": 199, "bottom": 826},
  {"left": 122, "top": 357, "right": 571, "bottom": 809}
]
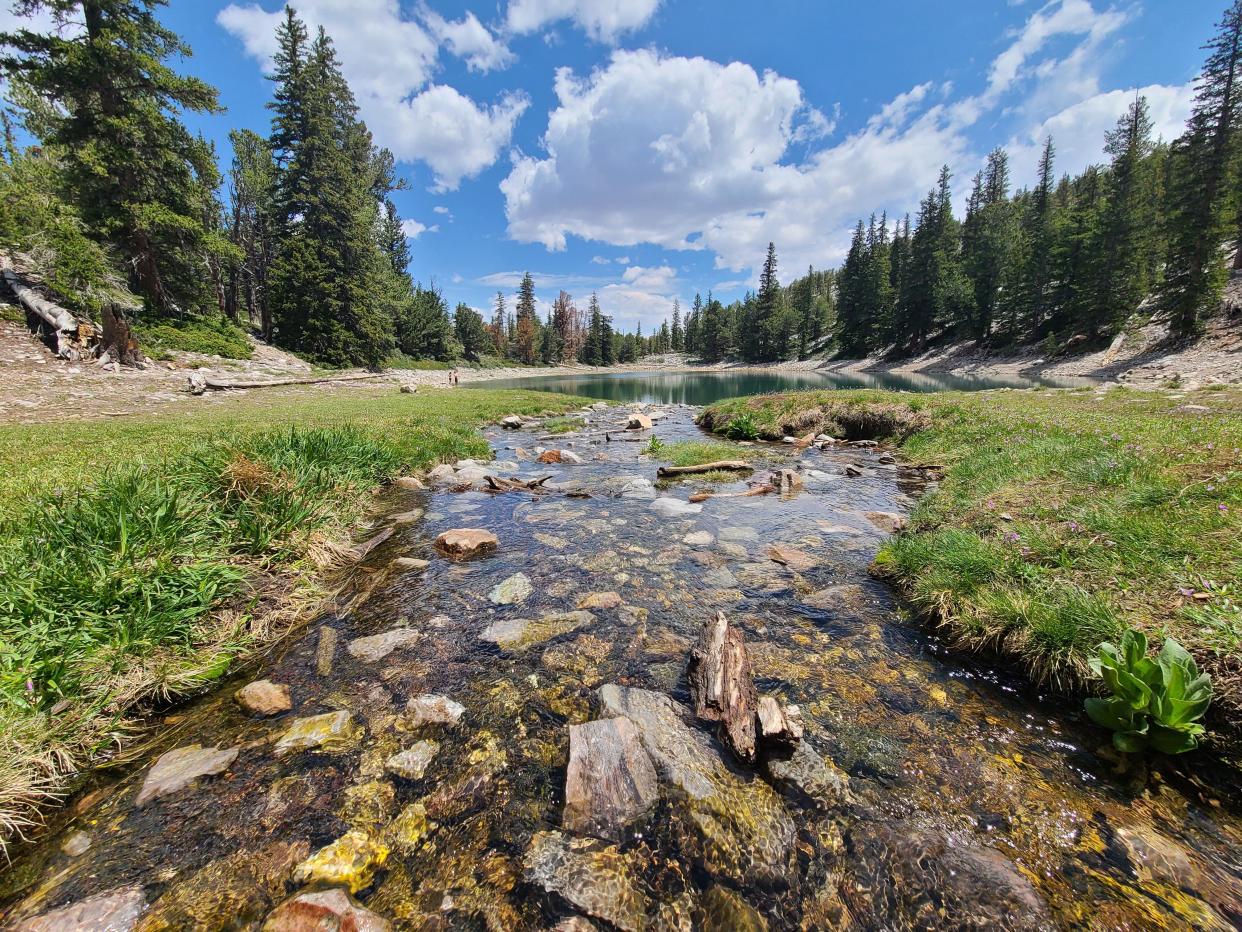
[{"left": 703, "top": 389, "right": 1242, "bottom": 717}]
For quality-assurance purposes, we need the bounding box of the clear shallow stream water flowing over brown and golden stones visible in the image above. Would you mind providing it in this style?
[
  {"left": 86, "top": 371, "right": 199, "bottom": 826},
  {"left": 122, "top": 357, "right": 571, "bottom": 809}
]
[{"left": 0, "top": 408, "right": 1242, "bottom": 930}]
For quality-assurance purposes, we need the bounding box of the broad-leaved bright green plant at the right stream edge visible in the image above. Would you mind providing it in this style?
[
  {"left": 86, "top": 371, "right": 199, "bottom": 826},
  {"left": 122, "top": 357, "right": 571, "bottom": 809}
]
[{"left": 1087, "top": 630, "right": 1212, "bottom": 754}]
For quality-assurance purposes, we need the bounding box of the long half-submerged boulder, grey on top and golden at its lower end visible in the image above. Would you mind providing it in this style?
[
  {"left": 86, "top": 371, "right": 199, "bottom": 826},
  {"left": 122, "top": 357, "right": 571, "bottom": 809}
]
[{"left": 599, "top": 683, "right": 796, "bottom": 887}]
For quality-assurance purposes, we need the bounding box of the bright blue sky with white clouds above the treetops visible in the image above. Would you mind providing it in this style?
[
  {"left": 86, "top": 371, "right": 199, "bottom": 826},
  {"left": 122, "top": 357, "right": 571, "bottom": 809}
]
[{"left": 0, "top": 0, "right": 1225, "bottom": 331}]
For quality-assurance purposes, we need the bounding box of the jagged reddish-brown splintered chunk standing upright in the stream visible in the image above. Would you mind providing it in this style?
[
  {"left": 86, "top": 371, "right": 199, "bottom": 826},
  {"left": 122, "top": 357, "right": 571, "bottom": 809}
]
[{"left": 686, "top": 611, "right": 759, "bottom": 762}]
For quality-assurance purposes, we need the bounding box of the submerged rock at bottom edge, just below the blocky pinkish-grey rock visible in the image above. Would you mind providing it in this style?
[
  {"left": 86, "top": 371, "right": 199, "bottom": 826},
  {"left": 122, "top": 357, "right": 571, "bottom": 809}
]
[{"left": 525, "top": 831, "right": 651, "bottom": 932}]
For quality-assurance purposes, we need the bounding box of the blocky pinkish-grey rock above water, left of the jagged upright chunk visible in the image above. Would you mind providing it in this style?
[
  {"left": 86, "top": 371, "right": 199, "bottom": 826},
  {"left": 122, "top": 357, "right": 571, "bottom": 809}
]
[{"left": 563, "top": 717, "right": 660, "bottom": 841}]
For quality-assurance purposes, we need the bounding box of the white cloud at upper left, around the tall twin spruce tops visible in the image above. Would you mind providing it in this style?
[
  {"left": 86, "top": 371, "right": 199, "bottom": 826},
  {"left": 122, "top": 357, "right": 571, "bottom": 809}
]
[{"left": 216, "top": 0, "right": 527, "bottom": 190}]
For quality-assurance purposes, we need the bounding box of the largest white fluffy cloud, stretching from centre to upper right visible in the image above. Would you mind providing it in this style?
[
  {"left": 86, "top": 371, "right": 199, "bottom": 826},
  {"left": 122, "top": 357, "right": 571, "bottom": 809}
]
[{"left": 501, "top": 0, "right": 1186, "bottom": 273}]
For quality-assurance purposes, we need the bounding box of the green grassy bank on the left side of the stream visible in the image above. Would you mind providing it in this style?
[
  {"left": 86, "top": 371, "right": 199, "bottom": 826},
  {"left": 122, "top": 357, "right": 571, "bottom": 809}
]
[{"left": 0, "top": 390, "right": 580, "bottom": 840}]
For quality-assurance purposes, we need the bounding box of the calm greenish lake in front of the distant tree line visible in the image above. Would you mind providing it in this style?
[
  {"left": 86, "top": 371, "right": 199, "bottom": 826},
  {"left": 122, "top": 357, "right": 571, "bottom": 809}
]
[{"left": 472, "top": 369, "right": 1089, "bottom": 405}]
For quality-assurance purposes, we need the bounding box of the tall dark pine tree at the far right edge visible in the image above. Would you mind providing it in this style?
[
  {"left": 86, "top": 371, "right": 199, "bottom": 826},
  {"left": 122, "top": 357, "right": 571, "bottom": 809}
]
[{"left": 1161, "top": 0, "right": 1242, "bottom": 334}]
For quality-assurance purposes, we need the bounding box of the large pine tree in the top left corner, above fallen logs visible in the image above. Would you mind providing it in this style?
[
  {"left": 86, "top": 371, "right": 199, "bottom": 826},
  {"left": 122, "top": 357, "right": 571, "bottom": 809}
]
[{"left": 0, "top": 0, "right": 233, "bottom": 313}]
